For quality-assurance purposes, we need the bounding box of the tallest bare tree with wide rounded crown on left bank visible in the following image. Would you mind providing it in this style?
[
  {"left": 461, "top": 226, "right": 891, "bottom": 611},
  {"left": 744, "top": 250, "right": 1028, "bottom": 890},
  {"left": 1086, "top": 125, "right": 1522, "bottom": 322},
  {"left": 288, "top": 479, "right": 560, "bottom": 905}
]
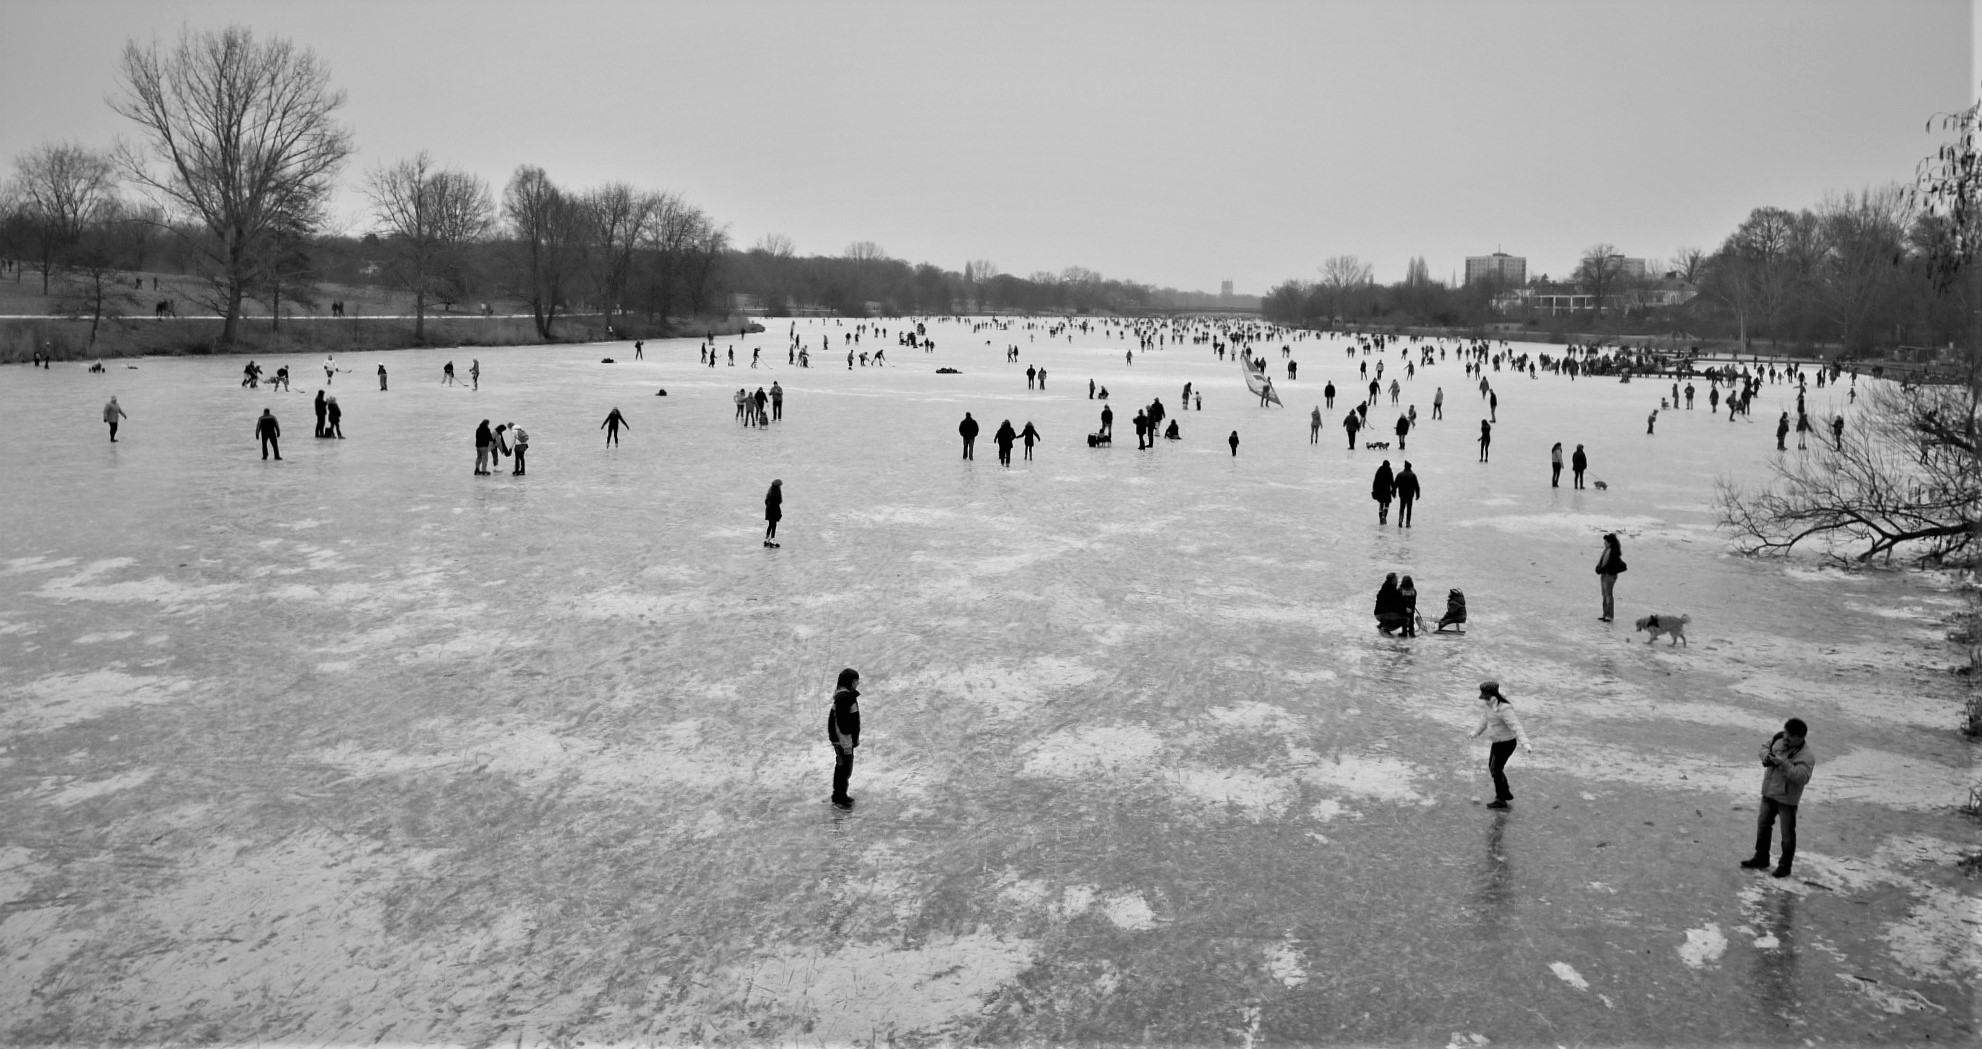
[{"left": 111, "top": 26, "right": 351, "bottom": 343}]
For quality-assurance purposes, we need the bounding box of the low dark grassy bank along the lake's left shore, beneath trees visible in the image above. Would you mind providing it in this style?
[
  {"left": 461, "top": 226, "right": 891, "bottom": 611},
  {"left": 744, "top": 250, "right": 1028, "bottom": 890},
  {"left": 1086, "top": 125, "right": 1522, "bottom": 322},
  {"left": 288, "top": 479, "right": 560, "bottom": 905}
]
[{"left": 0, "top": 315, "right": 751, "bottom": 363}]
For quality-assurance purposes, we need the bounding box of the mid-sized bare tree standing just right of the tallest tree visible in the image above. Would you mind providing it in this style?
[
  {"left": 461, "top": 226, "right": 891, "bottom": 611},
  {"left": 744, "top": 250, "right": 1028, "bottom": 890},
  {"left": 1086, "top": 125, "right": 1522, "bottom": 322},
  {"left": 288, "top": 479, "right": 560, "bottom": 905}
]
[{"left": 365, "top": 151, "right": 496, "bottom": 341}]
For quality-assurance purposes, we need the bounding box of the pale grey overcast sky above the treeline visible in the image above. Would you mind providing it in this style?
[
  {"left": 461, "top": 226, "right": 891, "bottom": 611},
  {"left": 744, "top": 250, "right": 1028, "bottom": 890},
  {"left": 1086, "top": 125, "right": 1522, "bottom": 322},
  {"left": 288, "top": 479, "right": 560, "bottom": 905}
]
[{"left": 0, "top": 0, "right": 1978, "bottom": 293}]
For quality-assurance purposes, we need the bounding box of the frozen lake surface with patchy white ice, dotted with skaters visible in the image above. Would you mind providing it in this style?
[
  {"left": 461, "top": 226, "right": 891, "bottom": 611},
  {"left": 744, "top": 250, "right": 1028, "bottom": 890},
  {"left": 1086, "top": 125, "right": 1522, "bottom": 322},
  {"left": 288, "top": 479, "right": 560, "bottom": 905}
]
[{"left": 0, "top": 321, "right": 1982, "bottom": 1045}]
